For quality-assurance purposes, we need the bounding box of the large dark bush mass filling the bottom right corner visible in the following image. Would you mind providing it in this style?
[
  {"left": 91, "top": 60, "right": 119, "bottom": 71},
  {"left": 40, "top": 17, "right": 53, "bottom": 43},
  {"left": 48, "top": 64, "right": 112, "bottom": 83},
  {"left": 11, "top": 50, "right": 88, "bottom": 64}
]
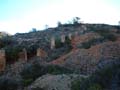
[{"left": 80, "top": 59, "right": 120, "bottom": 90}]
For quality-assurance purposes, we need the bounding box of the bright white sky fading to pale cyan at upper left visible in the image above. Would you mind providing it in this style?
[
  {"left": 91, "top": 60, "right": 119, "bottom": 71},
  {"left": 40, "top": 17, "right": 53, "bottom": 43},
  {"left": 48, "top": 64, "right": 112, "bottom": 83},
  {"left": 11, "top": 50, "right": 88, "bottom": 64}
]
[{"left": 0, "top": 0, "right": 120, "bottom": 34}]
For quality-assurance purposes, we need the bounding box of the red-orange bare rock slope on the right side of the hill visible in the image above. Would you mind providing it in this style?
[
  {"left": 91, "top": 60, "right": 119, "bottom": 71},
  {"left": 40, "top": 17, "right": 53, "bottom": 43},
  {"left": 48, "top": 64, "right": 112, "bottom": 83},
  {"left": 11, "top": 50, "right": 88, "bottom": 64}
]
[{"left": 51, "top": 33, "right": 120, "bottom": 73}]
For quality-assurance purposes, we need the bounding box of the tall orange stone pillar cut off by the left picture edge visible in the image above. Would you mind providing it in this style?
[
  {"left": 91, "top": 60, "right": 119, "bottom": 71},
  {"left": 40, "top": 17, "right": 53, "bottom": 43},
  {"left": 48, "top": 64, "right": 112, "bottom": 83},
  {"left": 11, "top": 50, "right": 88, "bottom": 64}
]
[{"left": 0, "top": 50, "right": 6, "bottom": 72}]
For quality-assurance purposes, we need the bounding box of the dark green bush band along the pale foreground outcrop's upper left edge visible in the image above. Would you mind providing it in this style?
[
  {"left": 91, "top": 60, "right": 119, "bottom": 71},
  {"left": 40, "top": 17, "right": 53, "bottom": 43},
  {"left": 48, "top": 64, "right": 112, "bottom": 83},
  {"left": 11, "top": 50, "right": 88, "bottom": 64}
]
[{"left": 20, "top": 62, "right": 72, "bottom": 86}]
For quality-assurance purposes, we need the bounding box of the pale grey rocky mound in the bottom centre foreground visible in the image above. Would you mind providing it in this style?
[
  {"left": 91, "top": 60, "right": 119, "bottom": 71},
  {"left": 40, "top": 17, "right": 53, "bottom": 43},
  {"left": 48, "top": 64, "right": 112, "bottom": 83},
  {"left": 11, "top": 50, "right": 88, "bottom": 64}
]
[{"left": 25, "top": 74, "right": 87, "bottom": 90}]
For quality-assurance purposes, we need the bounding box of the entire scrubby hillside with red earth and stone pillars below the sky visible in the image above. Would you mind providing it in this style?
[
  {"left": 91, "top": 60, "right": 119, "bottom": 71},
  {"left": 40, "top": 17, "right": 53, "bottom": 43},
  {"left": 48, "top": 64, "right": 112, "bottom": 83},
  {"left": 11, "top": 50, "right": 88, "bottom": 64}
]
[{"left": 0, "top": 24, "right": 120, "bottom": 90}]
